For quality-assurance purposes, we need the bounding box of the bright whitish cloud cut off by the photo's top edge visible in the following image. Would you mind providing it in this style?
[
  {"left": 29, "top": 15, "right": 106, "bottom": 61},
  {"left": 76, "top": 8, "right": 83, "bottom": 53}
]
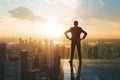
[{"left": 45, "top": 0, "right": 82, "bottom": 9}]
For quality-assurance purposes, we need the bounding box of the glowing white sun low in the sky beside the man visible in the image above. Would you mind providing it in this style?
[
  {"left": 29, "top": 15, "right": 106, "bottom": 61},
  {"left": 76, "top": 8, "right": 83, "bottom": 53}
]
[{"left": 44, "top": 20, "right": 64, "bottom": 38}]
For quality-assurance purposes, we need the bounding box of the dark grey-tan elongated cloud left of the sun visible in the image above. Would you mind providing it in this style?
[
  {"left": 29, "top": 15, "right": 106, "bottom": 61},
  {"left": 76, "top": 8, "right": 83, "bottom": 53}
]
[{"left": 9, "top": 7, "right": 47, "bottom": 22}]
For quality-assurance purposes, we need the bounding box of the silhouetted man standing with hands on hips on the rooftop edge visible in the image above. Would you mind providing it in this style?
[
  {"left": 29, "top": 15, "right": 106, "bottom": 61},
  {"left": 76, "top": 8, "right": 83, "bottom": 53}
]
[{"left": 65, "top": 21, "right": 87, "bottom": 64}]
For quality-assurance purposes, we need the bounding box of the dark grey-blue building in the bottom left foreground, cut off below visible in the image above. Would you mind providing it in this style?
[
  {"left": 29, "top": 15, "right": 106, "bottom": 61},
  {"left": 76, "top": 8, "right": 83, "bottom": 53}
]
[{"left": 4, "top": 58, "right": 21, "bottom": 80}]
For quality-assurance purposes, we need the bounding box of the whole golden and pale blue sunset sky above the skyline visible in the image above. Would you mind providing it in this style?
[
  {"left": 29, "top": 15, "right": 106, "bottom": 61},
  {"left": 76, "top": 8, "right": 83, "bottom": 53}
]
[{"left": 0, "top": 0, "right": 120, "bottom": 39}]
